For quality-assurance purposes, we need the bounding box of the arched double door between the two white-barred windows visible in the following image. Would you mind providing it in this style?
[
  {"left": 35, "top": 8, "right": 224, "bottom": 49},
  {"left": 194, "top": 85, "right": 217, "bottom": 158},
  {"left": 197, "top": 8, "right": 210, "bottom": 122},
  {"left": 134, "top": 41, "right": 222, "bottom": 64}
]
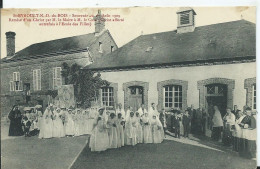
[{"left": 128, "top": 86, "right": 144, "bottom": 111}]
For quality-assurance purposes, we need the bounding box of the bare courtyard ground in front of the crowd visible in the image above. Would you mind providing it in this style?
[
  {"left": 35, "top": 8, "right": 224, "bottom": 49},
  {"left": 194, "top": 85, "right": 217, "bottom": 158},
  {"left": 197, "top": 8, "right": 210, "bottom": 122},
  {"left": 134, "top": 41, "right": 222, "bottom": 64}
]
[{"left": 1, "top": 120, "right": 256, "bottom": 169}]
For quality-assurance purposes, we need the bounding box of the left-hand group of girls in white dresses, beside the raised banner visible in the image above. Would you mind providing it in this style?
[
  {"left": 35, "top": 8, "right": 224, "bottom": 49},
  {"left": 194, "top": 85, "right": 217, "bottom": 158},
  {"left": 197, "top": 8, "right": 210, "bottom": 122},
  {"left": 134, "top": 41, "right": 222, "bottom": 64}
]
[{"left": 39, "top": 104, "right": 96, "bottom": 138}]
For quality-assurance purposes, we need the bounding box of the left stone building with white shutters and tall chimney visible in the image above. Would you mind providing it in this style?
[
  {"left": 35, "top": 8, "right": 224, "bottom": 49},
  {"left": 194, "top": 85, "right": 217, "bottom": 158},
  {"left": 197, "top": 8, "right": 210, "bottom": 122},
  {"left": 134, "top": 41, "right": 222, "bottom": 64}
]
[{"left": 0, "top": 10, "right": 118, "bottom": 115}]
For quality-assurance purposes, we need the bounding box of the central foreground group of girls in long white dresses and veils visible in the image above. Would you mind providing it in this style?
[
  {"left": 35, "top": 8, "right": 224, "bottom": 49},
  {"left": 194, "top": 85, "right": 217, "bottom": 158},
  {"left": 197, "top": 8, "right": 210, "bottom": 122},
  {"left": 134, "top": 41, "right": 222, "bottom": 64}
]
[{"left": 89, "top": 104, "right": 164, "bottom": 152}]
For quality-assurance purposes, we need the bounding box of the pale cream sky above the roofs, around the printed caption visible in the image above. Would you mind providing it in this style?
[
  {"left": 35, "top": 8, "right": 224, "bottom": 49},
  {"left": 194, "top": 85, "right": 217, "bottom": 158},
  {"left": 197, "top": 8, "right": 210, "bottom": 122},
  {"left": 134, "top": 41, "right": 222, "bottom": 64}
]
[{"left": 1, "top": 7, "right": 256, "bottom": 58}]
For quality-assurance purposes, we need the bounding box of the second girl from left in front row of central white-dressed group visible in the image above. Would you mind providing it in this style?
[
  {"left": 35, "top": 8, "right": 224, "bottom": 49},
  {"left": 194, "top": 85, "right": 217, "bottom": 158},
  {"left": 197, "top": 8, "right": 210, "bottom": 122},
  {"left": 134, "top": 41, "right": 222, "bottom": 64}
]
[{"left": 107, "top": 113, "right": 118, "bottom": 148}]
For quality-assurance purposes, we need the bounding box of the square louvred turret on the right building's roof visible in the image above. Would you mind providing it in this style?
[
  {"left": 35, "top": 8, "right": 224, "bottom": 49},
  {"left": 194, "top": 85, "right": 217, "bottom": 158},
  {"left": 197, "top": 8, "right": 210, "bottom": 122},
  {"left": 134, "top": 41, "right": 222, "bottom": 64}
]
[{"left": 176, "top": 7, "right": 196, "bottom": 33}]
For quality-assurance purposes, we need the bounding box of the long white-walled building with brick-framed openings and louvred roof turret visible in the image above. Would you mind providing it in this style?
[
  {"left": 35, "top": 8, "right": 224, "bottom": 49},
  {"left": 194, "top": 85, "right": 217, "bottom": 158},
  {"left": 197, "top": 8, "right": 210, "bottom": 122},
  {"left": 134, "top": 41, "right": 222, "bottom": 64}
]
[{"left": 85, "top": 8, "right": 256, "bottom": 114}]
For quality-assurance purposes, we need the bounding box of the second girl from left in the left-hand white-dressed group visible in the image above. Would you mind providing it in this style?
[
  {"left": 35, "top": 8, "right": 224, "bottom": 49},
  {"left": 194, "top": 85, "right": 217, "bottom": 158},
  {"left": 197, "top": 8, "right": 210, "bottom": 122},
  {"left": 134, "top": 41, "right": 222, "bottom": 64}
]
[{"left": 52, "top": 108, "right": 65, "bottom": 137}]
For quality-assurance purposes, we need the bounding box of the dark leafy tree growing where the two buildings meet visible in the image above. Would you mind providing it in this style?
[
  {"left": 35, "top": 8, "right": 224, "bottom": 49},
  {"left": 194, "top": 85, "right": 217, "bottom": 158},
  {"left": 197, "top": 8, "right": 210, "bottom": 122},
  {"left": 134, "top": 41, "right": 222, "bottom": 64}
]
[{"left": 62, "top": 63, "right": 109, "bottom": 107}]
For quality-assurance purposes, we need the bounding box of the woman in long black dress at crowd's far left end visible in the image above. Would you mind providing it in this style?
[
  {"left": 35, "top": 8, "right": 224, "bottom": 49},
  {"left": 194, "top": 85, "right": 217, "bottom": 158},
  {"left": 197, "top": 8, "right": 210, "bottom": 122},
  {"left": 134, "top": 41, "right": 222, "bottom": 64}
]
[{"left": 8, "top": 105, "right": 24, "bottom": 136}]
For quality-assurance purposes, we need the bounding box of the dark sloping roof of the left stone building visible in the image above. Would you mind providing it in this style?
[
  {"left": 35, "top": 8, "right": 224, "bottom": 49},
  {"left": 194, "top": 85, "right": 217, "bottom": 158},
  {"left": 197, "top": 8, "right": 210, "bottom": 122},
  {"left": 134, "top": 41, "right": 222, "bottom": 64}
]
[{"left": 2, "top": 30, "right": 104, "bottom": 61}]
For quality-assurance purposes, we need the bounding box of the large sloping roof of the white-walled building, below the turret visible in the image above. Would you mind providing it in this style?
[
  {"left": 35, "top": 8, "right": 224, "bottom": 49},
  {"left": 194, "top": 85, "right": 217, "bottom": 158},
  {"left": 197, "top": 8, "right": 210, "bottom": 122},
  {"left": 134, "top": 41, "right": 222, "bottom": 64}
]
[{"left": 85, "top": 20, "right": 256, "bottom": 70}]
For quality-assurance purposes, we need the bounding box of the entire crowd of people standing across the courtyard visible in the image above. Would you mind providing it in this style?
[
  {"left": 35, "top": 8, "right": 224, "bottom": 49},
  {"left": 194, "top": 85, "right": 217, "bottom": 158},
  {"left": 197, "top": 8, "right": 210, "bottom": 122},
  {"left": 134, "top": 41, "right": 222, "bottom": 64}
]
[{"left": 8, "top": 103, "right": 256, "bottom": 156}]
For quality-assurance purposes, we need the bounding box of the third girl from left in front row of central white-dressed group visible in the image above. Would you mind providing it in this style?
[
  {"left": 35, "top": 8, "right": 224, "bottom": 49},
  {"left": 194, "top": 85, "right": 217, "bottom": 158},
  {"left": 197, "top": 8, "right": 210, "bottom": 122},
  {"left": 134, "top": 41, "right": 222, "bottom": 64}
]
[{"left": 116, "top": 113, "right": 125, "bottom": 147}]
